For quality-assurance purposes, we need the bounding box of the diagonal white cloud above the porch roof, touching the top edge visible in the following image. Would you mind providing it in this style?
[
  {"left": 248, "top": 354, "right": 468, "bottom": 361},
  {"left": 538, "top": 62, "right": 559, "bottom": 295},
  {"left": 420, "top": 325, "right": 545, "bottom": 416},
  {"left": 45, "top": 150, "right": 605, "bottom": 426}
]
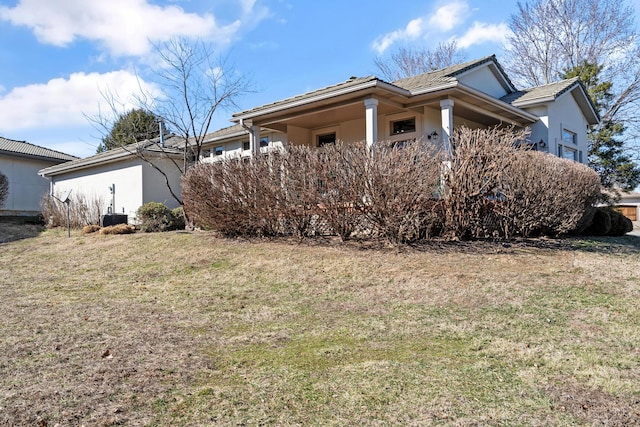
[{"left": 372, "top": 0, "right": 470, "bottom": 54}]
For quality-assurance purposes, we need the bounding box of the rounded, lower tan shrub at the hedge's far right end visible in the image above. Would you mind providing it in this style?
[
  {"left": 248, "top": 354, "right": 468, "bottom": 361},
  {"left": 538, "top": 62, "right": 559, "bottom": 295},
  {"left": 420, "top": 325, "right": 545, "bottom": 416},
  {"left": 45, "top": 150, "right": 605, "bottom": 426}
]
[{"left": 500, "top": 151, "right": 601, "bottom": 237}]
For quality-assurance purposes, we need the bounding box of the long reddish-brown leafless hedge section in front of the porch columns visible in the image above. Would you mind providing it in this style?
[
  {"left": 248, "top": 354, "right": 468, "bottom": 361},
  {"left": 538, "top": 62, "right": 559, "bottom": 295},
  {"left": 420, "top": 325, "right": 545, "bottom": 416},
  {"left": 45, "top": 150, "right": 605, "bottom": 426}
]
[{"left": 183, "top": 142, "right": 441, "bottom": 243}]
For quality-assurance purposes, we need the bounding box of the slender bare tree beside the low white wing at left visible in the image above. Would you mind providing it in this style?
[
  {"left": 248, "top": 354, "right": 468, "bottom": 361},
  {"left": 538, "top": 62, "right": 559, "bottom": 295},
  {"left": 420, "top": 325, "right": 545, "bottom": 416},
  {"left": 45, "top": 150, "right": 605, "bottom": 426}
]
[{"left": 89, "top": 37, "right": 252, "bottom": 205}]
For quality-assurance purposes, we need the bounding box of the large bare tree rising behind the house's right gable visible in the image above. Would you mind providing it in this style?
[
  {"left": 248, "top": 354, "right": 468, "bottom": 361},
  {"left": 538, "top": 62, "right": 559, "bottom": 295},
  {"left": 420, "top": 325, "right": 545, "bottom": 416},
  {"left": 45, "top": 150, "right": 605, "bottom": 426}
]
[{"left": 505, "top": 0, "right": 640, "bottom": 178}]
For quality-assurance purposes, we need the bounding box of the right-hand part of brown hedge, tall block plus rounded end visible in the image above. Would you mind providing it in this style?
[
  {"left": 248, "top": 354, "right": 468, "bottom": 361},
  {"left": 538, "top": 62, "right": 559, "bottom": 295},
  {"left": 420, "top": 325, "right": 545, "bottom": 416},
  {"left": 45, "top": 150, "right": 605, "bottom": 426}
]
[{"left": 445, "top": 128, "right": 601, "bottom": 239}]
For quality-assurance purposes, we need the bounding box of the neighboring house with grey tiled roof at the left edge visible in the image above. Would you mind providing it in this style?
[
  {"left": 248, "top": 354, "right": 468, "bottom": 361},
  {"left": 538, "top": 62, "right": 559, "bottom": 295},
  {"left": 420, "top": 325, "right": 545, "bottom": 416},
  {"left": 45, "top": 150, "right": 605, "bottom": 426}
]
[{"left": 0, "top": 137, "right": 77, "bottom": 216}]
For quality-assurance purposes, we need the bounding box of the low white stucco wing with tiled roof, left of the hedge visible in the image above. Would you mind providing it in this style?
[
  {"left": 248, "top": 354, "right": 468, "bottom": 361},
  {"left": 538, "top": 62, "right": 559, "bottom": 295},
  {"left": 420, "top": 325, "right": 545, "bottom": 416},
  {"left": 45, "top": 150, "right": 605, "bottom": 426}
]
[{"left": 39, "top": 141, "right": 183, "bottom": 222}]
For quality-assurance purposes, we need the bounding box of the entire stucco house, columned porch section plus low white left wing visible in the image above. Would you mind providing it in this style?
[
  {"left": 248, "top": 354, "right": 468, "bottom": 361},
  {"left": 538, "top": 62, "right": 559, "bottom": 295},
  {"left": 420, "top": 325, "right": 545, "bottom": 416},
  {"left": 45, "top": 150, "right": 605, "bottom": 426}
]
[{"left": 40, "top": 56, "right": 599, "bottom": 221}]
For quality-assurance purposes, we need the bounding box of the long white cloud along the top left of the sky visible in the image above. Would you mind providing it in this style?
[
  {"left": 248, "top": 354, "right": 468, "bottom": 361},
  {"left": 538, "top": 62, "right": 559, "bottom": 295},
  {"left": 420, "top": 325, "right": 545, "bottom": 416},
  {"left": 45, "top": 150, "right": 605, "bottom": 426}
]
[{"left": 0, "top": 0, "right": 267, "bottom": 56}]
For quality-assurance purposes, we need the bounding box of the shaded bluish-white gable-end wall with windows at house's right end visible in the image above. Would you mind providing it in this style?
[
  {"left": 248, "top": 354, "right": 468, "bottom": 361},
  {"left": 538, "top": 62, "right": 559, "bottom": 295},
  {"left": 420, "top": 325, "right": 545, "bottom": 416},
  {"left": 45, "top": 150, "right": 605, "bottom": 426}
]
[{"left": 548, "top": 93, "right": 588, "bottom": 164}]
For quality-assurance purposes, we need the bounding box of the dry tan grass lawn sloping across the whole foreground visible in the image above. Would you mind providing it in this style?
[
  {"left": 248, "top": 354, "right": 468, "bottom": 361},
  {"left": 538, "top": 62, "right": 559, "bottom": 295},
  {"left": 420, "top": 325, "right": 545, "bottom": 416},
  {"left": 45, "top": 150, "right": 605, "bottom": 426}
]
[{"left": 0, "top": 226, "right": 640, "bottom": 426}]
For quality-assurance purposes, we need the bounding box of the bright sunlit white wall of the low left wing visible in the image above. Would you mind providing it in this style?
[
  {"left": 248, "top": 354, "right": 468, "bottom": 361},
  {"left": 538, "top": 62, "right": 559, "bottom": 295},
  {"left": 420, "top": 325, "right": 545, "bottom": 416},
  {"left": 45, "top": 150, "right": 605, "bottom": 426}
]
[{"left": 52, "top": 159, "right": 145, "bottom": 218}]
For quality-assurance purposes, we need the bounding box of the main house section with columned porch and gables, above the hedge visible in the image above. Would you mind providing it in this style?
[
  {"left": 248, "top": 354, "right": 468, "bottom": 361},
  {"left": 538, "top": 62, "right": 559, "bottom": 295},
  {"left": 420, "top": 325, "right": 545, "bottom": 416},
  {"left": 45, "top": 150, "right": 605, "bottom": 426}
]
[{"left": 204, "top": 56, "right": 599, "bottom": 163}]
